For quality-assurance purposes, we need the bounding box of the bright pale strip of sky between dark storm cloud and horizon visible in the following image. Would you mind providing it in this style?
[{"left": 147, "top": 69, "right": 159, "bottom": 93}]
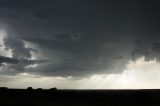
[{"left": 0, "top": 57, "right": 160, "bottom": 89}]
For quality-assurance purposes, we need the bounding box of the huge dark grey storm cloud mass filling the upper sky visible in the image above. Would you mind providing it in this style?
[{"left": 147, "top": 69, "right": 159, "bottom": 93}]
[{"left": 0, "top": 0, "right": 160, "bottom": 76}]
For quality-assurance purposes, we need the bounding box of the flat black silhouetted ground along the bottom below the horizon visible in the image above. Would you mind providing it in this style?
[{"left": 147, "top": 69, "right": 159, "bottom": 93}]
[{"left": 0, "top": 88, "right": 160, "bottom": 106}]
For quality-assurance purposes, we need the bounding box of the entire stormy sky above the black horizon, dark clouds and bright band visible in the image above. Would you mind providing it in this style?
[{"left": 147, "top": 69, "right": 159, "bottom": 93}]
[{"left": 0, "top": 0, "right": 160, "bottom": 89}]
